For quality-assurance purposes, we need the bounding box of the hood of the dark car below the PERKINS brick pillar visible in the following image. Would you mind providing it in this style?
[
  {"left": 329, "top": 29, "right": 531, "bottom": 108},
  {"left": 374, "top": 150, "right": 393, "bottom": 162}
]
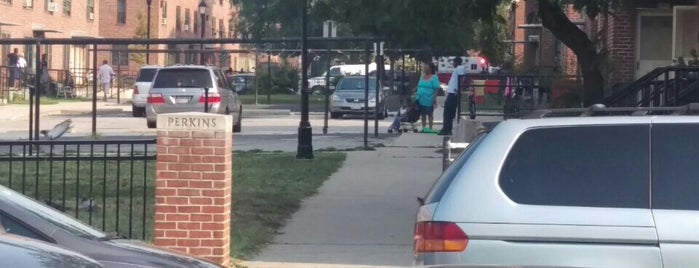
[{"left": 90, "top": 239, "right": 221, "bottom": 268}]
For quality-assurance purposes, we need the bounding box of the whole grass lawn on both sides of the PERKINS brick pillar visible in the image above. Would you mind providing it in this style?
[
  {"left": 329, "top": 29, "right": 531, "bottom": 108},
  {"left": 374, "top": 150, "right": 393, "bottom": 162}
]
[{"left": 0, "top": 152, "right": 345, "bottom": 259}]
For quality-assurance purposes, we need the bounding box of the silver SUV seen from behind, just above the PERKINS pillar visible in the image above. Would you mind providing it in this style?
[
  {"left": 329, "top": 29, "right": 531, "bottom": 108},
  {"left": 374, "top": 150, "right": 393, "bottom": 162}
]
[{"left": 146, "top": 65, "right": 243, "bottom": 132}]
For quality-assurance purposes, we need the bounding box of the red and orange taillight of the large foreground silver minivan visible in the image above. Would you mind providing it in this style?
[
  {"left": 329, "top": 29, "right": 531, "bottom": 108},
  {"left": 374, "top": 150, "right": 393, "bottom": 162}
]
[{"left": 414, "top": 222, "right": 468, "bottom": 253}]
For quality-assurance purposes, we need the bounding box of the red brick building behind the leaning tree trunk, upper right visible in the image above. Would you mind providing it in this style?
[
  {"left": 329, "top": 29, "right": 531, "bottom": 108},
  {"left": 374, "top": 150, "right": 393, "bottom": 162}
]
[{"left": 510, "top": 0, "right": 699, "bottom": 87}]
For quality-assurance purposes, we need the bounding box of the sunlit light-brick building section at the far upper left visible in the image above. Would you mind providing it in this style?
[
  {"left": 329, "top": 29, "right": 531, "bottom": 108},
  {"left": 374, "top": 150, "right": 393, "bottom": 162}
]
[{"left": 0, "top": 0, "right": 99, "bottom": 74}]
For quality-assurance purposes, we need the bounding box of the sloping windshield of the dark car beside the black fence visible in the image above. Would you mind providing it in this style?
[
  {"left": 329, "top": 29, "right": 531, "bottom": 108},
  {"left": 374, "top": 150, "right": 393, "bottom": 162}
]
[{"left": 0, "top": 186, "right": 107, "bottom": 239}]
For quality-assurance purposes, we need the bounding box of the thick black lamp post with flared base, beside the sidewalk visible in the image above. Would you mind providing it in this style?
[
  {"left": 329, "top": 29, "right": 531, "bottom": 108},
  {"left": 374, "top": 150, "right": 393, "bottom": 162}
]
[{"left": 296, "top": 0, "right": 313, "bottom": 159}]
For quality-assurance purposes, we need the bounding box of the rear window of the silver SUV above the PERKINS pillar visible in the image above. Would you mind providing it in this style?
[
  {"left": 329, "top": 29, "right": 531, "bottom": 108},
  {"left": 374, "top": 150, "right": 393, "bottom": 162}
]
[{"left": 153, "top": 68, "right": 213, "bottom": 88}]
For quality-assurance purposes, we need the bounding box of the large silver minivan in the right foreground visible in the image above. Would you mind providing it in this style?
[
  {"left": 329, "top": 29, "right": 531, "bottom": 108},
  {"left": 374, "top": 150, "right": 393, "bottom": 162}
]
[{"left": 414, "top": 108, "right": 699, "bottom": 268}]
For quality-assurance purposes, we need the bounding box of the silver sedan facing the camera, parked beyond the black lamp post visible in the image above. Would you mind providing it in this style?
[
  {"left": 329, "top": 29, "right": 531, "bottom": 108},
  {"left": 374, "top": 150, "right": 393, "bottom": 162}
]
[{"left": 330, "top": 76, "right": 388, "bottom": 119}]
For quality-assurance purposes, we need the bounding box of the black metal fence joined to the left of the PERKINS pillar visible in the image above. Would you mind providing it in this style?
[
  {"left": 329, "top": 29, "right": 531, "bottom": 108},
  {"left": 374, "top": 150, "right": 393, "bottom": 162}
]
[{"left": 0, "top": 139, "right": 156, "bottom": 240}]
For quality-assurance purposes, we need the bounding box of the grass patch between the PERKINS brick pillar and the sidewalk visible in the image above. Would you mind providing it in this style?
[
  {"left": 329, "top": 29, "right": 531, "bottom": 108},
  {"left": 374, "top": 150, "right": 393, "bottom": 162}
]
[{"left": 231, "top": 152, "right": 345, "bottom": 259}]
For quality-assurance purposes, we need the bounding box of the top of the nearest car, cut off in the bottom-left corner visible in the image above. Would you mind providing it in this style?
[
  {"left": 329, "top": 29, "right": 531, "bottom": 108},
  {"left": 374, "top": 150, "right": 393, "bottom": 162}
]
[{"left": 0, "top": 232, "right": 102, "bottom": 268}]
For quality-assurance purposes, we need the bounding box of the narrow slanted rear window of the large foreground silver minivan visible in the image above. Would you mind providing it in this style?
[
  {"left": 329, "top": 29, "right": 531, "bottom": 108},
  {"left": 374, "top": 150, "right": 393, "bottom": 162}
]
[{"left": 425, "top": 133, "right": 488, "bottom": 204}]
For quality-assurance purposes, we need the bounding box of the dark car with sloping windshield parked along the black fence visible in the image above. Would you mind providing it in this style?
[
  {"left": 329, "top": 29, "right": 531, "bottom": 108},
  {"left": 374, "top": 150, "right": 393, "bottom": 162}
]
[{"left": 0, "top": 186, "right": 220, "bottom": 268}]
